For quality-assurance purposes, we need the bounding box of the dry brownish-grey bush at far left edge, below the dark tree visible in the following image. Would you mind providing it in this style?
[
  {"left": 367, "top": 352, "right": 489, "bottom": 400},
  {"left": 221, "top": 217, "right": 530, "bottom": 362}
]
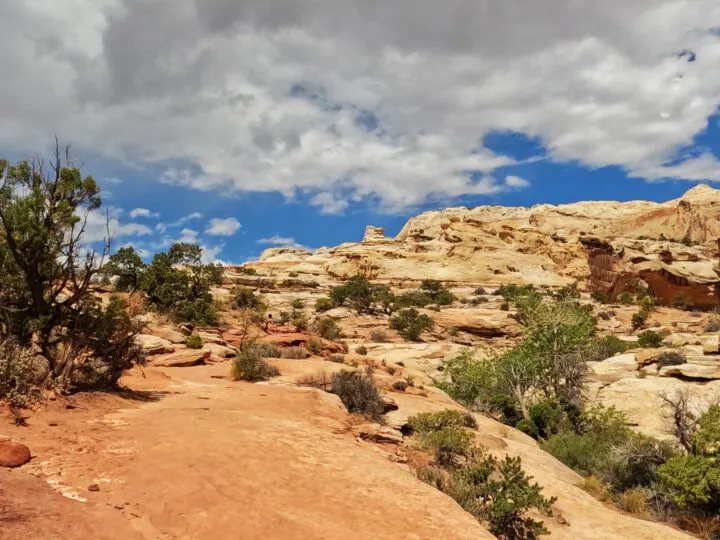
[{"left": 0, "top": 339, "right": 42, "bottom": 407}]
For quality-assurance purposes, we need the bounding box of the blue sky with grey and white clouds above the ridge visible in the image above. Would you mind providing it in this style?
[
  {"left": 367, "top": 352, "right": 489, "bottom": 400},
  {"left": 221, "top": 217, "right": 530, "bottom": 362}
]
[{"left": 0, "top": 0, "right": 720, "bottom": 264}]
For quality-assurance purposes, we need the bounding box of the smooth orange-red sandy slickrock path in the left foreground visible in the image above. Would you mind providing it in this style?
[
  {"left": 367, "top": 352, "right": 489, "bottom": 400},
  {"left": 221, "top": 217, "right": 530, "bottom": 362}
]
[{"left": 0, "top": 364, "right": 492, "bottom": 540}]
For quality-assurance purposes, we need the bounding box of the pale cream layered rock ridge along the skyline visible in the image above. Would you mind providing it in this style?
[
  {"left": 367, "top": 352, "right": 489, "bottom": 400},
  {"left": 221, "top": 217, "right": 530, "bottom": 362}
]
[{"left": 240, "top": 185, "right": 720, "bottom": 307}]
